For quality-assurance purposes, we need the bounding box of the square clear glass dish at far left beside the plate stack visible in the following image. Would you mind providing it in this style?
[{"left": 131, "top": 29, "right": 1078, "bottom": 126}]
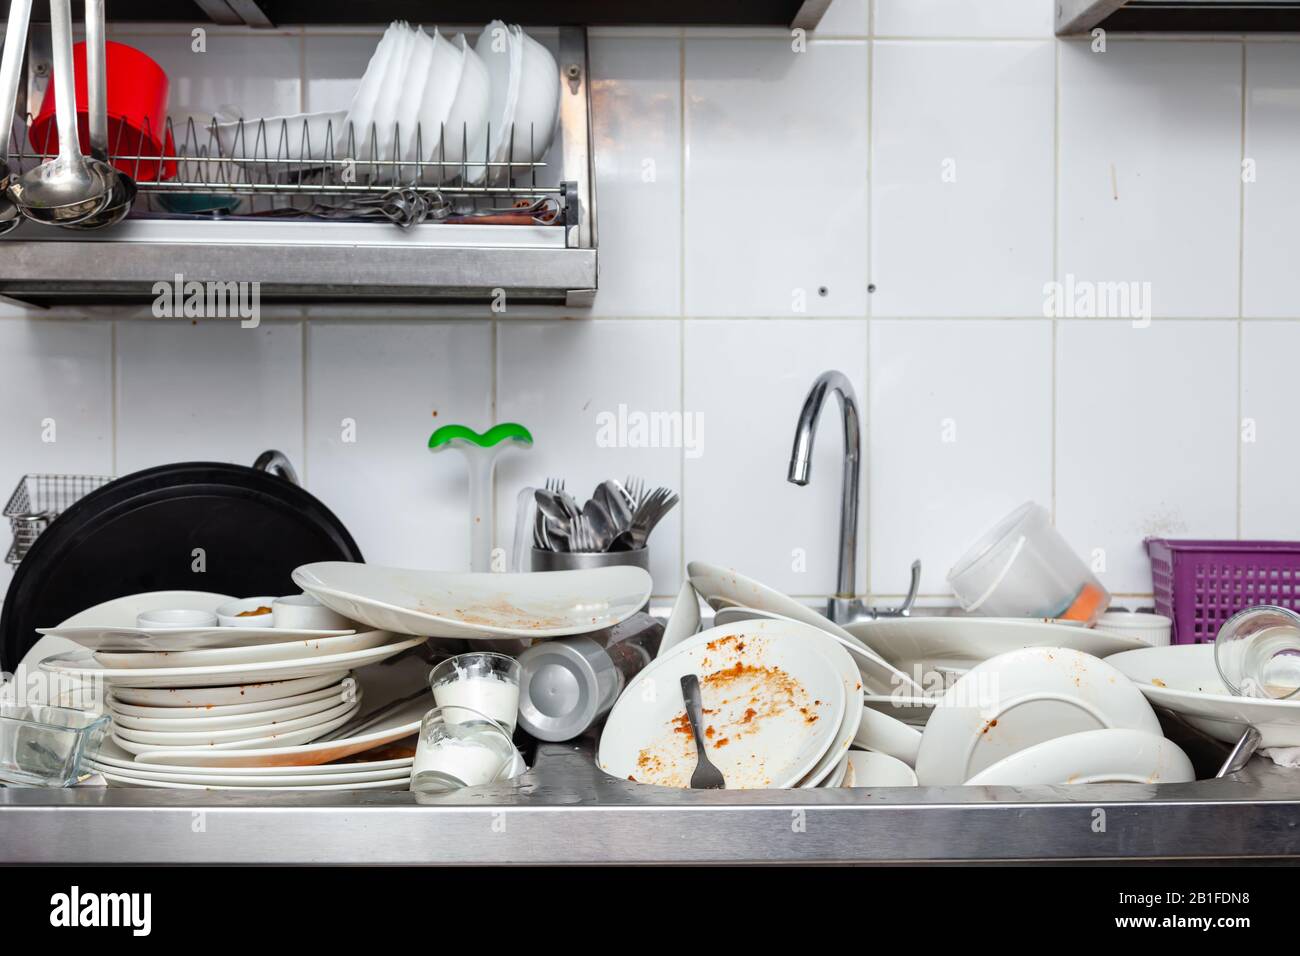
[{"left": 0, "top": 704, "right": 109, "bottom": 787}]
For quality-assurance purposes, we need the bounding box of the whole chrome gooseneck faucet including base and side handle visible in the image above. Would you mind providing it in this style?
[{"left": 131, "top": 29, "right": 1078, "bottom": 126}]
[{"left": 787, "top": 371, "right": 920, "bottom": 624}]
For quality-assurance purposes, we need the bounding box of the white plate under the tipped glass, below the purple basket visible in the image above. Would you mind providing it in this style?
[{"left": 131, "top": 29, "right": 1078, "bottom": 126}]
[{"left": 1108, "top": 644, "right": 1300, "bottom": 747}]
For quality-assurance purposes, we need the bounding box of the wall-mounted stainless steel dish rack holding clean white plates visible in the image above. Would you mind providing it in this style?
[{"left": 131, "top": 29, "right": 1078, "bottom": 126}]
[{"left": 0, "top": 27, "right": 597, "bottom": 306}]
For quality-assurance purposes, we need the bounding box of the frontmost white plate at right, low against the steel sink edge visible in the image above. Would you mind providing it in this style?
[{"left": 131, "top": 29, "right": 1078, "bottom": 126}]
[{"left": 966, "top": 730, "right": 1196, "bottom": 787}]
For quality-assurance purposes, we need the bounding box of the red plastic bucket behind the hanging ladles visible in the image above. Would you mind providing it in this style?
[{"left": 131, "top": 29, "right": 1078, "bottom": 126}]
[{"left": 29, "top": 40, "right": 176, "bottom": 181}]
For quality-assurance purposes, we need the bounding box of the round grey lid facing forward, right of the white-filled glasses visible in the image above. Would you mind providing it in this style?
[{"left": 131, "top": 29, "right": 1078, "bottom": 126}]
[{"left": 519, "top": 641, "right": 601, "bottom": 741}]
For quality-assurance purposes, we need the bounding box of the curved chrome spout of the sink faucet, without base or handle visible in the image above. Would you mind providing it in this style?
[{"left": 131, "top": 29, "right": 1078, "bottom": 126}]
[{"left": 788, "top": 371, "right": 862, "bottom": 598}]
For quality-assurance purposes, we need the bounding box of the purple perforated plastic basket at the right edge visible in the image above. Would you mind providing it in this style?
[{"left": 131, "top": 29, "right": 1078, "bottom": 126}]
[{"left": 1147, "top": 537, "right": 1300, "bottom": 644}]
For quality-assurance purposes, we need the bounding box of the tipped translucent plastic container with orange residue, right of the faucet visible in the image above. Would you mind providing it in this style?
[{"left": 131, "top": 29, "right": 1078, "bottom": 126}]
[{"left": 948, "top": 501, "right": 1110, "bottom": 624}]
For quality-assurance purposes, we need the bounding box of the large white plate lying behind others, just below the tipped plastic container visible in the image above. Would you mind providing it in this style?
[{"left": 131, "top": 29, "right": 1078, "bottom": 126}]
[{"left": 845, "top": 617, "right": 1147, "bottom": 674}]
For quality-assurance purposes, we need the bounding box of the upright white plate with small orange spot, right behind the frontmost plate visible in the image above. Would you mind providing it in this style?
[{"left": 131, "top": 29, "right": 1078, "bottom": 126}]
[{"left": 917, "top": 648, "right": 1161, "bottom": 787}]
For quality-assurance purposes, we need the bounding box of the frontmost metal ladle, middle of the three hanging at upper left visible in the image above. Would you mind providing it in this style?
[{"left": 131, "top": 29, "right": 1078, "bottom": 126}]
[{"left": 9, "top": 0, "right": 114, "bottom": 225}]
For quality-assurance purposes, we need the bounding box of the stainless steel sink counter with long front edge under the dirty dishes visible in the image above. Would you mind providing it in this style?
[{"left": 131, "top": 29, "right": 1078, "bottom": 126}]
[{"left": 0, "top": 744, "right": 1300, "bottom": 864}]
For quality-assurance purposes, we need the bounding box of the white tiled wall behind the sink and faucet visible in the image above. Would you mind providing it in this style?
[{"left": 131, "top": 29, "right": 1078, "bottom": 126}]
[{"left": 0, "top": 0, "right": 1300, "bottom": 600}]
